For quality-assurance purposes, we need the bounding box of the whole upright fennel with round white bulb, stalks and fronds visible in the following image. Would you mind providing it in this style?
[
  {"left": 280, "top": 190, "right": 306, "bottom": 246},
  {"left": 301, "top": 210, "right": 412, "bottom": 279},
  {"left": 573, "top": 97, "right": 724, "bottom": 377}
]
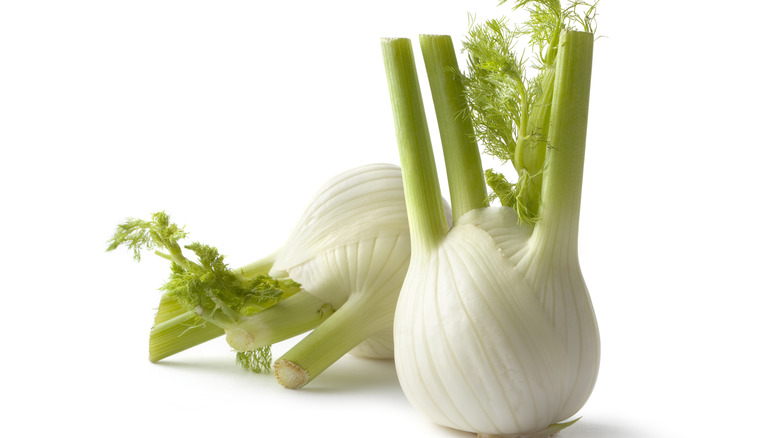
[{"left": 383, "top": 2, "right": 599, "bottom": 436}]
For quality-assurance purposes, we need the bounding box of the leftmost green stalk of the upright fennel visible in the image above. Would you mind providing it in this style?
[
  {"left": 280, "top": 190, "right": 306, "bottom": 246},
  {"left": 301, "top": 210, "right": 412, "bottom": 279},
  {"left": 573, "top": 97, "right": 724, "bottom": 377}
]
[{"left": 382, "top": 38, "right": 448, "bottom": 253}]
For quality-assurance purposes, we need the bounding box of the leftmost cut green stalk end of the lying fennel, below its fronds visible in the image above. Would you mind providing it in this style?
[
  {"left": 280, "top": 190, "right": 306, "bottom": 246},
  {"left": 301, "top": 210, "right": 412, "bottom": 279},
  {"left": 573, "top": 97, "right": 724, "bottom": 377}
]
[{"left": 149, "top": 294, "right": 225, "bottom": 362}]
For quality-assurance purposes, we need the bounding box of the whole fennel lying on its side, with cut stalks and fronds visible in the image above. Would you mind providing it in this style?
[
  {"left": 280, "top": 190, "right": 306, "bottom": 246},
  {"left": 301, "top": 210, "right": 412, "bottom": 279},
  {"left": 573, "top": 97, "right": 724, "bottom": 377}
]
[{"left": 109, "top": 164, "right": 450, "bottom": 388}]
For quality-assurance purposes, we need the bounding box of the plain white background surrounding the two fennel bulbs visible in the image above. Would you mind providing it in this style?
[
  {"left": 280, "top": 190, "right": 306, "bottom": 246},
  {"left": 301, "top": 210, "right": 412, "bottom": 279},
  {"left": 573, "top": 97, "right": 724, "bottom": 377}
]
[{"left": 0, "top": 0, "right": 780, "bottom": 438}]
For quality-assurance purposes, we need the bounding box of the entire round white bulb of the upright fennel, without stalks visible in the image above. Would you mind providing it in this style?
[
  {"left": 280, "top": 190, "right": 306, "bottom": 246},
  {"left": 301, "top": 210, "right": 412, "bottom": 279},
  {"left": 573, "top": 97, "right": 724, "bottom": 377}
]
[{"left": 395, "top": 207, "right": 599, "bottom": 435}]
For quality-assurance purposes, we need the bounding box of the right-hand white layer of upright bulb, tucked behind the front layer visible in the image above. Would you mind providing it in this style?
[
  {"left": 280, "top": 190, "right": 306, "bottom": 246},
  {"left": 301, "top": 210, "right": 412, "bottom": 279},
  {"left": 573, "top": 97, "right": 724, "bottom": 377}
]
[{"left": 459, "top": 207, "right": 600, "bottom": 421}]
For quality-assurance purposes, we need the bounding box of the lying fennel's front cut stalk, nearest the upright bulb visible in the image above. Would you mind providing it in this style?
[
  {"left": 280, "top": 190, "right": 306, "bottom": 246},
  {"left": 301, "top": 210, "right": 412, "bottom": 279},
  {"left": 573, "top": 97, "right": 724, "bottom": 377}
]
[{"left": 274, "top": 298, "right": 393, "bottom": 389}]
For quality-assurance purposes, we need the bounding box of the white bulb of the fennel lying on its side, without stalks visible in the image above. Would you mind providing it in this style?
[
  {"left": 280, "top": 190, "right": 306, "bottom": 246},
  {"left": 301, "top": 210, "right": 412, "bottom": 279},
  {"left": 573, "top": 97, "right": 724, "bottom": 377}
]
[{"left": 271, "top": 164, "right": 411, "bottom": 359}]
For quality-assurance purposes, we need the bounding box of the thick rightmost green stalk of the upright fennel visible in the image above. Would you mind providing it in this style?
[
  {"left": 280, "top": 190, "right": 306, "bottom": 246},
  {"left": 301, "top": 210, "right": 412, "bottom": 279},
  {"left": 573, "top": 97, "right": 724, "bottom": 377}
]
[{"left": 534, "top": 31, "right": 593, "bottom": 255}]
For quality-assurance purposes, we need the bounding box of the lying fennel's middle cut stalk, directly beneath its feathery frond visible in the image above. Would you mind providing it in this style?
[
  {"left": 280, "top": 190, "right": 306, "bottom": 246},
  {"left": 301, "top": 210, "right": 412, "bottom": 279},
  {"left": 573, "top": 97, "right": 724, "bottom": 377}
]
[{"left": 227, "top": 291, "right": 335, "bottom": 351}]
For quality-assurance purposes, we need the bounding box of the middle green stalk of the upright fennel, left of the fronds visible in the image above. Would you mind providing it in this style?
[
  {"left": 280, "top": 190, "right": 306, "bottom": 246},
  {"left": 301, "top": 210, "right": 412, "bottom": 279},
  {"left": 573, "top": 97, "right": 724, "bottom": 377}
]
[{"left": 420, "top": 35, "right": 488, "bottom": 220}]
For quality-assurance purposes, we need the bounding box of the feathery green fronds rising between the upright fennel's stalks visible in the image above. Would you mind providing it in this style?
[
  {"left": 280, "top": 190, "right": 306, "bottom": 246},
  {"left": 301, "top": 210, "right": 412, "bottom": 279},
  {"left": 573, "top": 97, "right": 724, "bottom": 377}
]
[{"left": 463, "top": 0, "right": 596, "bottom": 223}]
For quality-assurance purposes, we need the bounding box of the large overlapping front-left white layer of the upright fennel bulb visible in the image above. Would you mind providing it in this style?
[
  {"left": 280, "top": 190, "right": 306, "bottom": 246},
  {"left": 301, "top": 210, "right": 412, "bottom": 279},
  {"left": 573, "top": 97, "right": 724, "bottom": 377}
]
[{"left": 395, "top": 219, "right": 568, "bottom": 434}]
